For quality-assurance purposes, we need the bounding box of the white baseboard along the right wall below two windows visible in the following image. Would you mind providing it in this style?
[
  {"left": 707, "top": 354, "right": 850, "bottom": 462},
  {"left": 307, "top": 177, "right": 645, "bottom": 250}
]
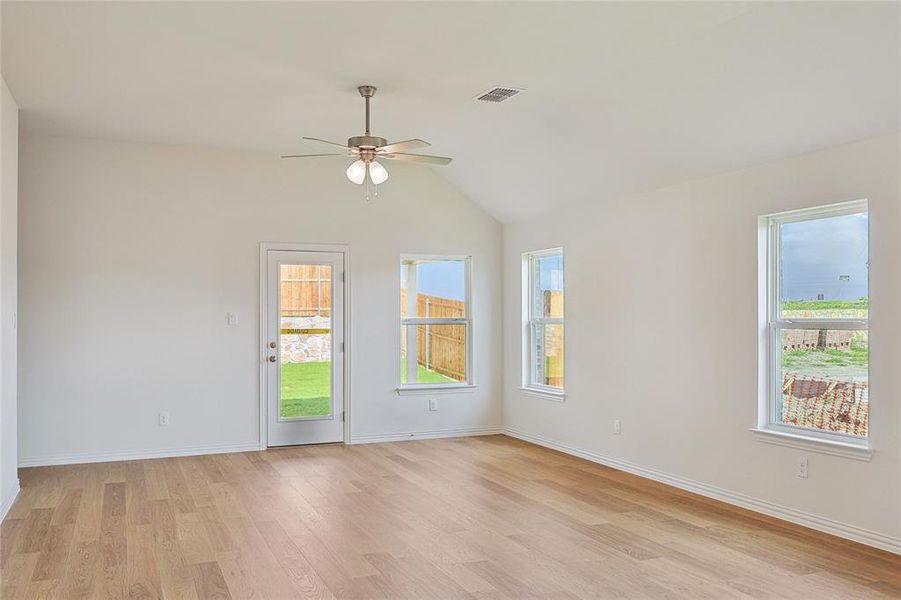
[{"left": 505, "top": 427, "right": 901, "bottom": 554}]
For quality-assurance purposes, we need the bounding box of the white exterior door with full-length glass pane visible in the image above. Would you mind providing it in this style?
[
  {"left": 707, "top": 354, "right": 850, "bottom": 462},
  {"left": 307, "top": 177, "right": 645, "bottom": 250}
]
[{"left": 264, "top": 250, "right": 344, "bottom": 446}]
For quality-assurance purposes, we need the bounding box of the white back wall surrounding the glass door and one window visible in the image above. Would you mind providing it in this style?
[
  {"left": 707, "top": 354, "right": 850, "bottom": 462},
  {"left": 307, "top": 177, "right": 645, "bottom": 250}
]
[{"left": 19, "top": 135, "right": 502, "bottom": 464}]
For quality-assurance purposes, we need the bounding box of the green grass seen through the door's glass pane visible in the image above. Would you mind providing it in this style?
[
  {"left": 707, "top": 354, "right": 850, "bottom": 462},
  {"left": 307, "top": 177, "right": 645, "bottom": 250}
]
[{"left": 281, "top": 362, "right": 332, "bottom": 419}]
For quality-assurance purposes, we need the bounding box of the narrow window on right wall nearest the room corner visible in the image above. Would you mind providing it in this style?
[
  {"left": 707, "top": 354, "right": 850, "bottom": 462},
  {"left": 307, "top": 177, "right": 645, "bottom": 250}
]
[{"left": 523, "top": 248, "right": 564, "bottom": 395}]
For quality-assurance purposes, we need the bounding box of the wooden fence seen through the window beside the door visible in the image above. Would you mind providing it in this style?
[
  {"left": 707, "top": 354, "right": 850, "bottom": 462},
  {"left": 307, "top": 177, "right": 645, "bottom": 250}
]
[{"left": 401, "top": 290, "right": 466, "bottom": 381}]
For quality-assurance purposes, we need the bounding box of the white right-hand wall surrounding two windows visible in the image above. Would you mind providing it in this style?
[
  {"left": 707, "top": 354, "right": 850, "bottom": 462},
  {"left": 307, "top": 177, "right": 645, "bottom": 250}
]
[{"left": 504, "top": 137, "right": 901, "bottom": 551}]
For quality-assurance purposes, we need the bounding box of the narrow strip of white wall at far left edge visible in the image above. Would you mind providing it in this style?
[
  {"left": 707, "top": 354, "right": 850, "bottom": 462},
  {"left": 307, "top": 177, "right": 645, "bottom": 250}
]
[{"left": 0, "top": 79, "right": 19, "bottom": 519}]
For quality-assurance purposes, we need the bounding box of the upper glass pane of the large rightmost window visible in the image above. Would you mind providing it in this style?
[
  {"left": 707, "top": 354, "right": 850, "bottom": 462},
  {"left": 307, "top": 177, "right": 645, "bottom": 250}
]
[{"left": 780, "top": 213, "right": 869, "bottom": 319}]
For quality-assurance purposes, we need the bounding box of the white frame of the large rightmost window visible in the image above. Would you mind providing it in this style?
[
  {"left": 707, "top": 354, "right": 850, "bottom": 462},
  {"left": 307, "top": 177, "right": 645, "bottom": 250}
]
[{"left": 754, "top": 199, "right": 872, "bottom": 453}]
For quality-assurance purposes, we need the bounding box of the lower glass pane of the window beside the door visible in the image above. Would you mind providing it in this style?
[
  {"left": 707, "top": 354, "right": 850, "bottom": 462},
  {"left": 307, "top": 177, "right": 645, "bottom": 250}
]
[{"left": 400, "top": 324, "right": 466, "bottom": 383}]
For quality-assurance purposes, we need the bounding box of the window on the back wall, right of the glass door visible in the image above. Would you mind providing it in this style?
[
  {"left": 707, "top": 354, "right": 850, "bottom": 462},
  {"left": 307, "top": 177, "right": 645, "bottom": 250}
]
[{"left": 400, "top": 256, "right": 472, "bottom": 388}]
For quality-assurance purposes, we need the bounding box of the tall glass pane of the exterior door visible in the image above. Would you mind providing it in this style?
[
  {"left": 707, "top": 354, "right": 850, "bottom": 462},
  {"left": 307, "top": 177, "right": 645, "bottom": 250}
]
[{"left": 279, "top": 265, "right": 332, "bottom": 419}]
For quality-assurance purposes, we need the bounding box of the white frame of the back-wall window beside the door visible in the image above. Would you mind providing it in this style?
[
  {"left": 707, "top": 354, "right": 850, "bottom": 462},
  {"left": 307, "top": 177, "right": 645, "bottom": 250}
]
[{"left": 394, "top": 254, "right": 477, "bottom": 396}]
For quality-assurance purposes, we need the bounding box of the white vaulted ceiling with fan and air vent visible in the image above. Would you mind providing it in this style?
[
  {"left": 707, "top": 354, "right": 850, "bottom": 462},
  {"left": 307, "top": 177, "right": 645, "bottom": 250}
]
[{"left": 2, "top": 1, "right": 899, "bottom": 222}]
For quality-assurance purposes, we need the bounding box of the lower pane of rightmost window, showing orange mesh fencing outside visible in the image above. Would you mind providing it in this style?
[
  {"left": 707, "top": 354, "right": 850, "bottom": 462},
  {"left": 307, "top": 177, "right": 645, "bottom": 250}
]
[{"left": 777, "top": 329, "right": 870, "bottom": 437}]
